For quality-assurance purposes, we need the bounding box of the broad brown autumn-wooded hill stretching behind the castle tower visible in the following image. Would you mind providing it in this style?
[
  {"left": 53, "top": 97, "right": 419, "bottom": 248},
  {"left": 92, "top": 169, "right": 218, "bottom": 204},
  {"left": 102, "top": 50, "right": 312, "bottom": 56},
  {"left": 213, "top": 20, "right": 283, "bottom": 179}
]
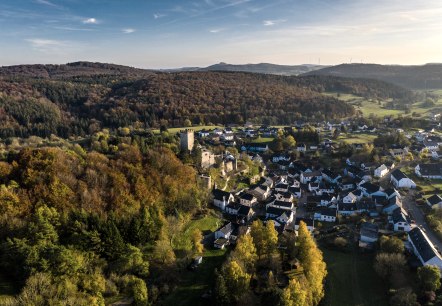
[{"left": 0, "top": 62, "right": 412, "bottom": 137}]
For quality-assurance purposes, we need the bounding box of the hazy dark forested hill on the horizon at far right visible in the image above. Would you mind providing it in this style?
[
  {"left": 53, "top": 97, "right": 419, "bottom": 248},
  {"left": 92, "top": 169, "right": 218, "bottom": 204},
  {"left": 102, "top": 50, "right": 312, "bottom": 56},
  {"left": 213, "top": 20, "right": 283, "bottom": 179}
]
[{"left": 305, "top": 64, "right": 442, "bottom": 89}]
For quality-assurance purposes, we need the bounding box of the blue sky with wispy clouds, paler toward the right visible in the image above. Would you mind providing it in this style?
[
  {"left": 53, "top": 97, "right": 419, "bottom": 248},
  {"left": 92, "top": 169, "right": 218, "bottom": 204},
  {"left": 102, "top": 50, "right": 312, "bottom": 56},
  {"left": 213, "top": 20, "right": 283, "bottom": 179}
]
[{"left": 0, "top": 0, "right": 442, "bottom": 68}]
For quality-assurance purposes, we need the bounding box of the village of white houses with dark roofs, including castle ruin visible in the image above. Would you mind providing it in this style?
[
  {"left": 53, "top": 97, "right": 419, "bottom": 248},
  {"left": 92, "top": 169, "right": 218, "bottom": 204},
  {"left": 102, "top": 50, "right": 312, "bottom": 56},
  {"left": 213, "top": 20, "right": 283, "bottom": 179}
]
[{"left": 174, "top": 115, "right": 442, "bottom": 296}]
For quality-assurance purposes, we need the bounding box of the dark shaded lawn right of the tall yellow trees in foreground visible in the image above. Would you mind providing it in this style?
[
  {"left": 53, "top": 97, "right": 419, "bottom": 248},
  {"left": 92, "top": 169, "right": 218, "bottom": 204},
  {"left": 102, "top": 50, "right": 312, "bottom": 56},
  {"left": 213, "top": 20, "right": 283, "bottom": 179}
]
[{"left": 321, "top": 247, "right": 388, "bottom": 306}]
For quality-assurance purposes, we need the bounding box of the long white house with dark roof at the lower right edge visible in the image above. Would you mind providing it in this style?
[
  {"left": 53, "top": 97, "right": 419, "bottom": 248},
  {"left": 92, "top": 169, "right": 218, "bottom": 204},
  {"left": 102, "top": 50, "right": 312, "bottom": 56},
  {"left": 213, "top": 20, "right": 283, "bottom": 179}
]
[{"left": 408, "top": 227, "right": 442, "bottom": 270}]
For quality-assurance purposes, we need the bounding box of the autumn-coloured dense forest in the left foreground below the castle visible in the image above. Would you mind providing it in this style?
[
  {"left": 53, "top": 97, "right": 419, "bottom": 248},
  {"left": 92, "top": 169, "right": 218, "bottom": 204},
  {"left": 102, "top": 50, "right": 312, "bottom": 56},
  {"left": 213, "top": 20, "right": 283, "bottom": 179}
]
[{"left": 0, "top": 144, "right": 207, "bottom": 305}]
